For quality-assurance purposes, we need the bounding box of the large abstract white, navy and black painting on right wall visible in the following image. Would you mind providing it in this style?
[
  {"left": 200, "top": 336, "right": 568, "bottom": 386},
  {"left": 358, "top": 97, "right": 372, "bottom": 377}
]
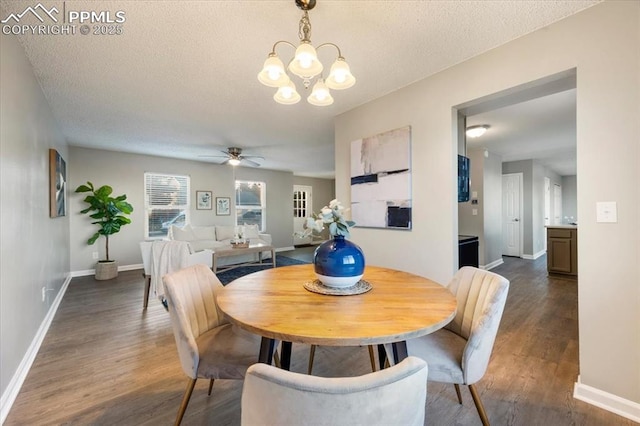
[{"left": 351, "top": 126, "right": 411, "bottom": 230}]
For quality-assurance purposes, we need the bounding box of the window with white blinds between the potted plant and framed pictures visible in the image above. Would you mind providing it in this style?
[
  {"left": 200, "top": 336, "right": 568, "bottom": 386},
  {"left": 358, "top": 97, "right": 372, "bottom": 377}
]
[{"left": 144, "top": 173, "right": 191, "bottom": 238}]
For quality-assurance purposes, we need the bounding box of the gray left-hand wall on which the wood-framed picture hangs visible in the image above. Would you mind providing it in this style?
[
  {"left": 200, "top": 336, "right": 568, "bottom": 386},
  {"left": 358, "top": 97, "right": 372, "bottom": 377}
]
[{"left": 0, "top": 35, "right": 69, "bottom": 399}]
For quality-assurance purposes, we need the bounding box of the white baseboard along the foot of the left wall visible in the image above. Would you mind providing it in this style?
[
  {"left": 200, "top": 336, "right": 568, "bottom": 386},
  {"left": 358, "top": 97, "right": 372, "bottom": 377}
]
[{"left": 0, "top": 274, "right": 72, "bottom": 424}]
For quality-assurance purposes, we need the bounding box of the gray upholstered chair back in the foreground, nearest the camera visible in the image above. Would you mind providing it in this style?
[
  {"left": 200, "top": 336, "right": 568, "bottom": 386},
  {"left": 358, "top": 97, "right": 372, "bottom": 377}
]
[{"left": 241, "top": 357, "right": 428, "bottom": 426}]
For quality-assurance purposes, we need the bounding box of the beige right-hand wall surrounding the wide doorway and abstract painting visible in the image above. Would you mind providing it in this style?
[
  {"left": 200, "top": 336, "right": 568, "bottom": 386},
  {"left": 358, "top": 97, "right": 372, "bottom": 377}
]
[{"left": 335, "top": 1, "right": 640, "bottom": 406}]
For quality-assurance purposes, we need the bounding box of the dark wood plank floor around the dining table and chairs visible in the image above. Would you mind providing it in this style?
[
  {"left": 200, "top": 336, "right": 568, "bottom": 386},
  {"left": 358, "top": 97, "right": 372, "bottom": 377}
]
[{"left": 5, "top": 255, "right": 634, "bottom": 426}]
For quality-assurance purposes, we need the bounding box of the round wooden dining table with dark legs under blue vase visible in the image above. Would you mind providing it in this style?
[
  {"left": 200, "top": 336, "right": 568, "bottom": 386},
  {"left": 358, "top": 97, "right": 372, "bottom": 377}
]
[{"left": 217, "top": 264, "right": 457, "bottom": 369}]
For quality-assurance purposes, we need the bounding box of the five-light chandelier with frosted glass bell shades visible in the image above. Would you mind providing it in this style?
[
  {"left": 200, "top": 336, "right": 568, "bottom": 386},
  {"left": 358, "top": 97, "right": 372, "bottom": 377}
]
[{"left": 258, "top": 0, "right": 356, "bottom": 106}]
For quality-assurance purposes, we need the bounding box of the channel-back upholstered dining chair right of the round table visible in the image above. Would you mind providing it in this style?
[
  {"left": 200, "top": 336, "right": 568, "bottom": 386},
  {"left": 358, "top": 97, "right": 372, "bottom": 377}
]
[{"left": 385, "top": 266, "right": 509, "bottom": 425}]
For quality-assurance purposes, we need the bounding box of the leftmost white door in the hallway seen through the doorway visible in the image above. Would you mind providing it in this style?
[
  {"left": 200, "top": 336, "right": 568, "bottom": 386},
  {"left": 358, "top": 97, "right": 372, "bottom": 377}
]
[{"left": 502, "top": 173, "right": 522, "bottom": 257}]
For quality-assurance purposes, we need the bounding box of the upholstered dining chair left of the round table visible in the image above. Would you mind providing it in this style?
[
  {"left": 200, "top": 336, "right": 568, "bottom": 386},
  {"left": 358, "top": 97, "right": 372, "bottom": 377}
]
[{"left": 163, "top": 264, "right": 268, "bottom": 425}]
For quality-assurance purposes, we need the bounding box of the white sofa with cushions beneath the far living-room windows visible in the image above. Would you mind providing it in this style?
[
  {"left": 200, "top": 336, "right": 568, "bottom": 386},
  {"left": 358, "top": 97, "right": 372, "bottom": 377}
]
[{"left": 168, "top": 225, "right": 272, "bottom": 267}]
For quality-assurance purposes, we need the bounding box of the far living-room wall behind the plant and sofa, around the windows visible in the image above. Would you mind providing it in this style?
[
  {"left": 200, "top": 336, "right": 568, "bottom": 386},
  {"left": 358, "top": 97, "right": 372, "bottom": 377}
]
[{"left": 69, "top": 147, "right": 293, "bottom": 271}]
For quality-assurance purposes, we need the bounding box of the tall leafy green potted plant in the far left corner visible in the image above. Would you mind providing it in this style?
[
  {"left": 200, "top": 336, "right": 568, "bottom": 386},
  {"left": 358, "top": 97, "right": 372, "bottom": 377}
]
[{"left": 76, "top": 182, "right": 133, "bottom": 280}]
